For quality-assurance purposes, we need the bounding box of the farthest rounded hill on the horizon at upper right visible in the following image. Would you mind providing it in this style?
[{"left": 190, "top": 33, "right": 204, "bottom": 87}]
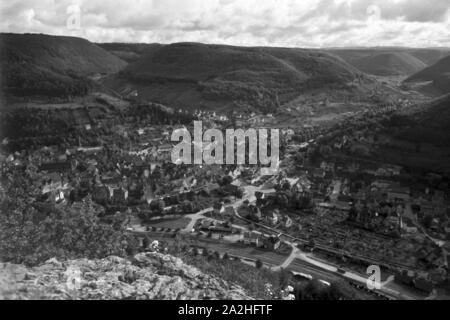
[{"left": 330, "top": 48, "right": 450, "bottom": 76}]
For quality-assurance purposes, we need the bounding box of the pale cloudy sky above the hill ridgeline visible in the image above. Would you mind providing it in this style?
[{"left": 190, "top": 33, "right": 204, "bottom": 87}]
[{"left": 0, "top": 0, "right": 450, "bottom": 47}]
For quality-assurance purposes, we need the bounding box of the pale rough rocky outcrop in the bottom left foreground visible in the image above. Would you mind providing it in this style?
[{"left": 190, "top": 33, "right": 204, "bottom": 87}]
[{"left": 0, "top": 252, "right": 250, "bottom": 300}]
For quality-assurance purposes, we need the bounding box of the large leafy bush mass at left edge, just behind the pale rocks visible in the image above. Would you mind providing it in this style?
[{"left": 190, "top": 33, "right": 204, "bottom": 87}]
[{"left": 0, "top": 196, "right": 137, "bottom": 265}]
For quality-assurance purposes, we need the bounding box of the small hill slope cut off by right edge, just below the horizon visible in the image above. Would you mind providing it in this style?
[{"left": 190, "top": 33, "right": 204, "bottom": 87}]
[{"left": 405, "top": 56, "right": 450, "bottom": 94}]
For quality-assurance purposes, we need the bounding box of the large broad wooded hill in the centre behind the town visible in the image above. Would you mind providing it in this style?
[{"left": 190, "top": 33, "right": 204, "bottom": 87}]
[{"left": 109, "top": 43, "right": 361, "bottom": 110}]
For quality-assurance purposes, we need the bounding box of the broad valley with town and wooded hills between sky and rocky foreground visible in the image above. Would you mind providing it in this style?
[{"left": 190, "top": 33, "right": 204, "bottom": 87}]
[{"left": 0, "top": 34, "right": 450, "bottom": 299}]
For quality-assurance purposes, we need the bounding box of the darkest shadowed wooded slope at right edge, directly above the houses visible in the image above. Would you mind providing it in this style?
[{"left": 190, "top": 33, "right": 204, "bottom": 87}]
[{"left": 374, "top": 95, "right": 450, "bottom": 174}]
